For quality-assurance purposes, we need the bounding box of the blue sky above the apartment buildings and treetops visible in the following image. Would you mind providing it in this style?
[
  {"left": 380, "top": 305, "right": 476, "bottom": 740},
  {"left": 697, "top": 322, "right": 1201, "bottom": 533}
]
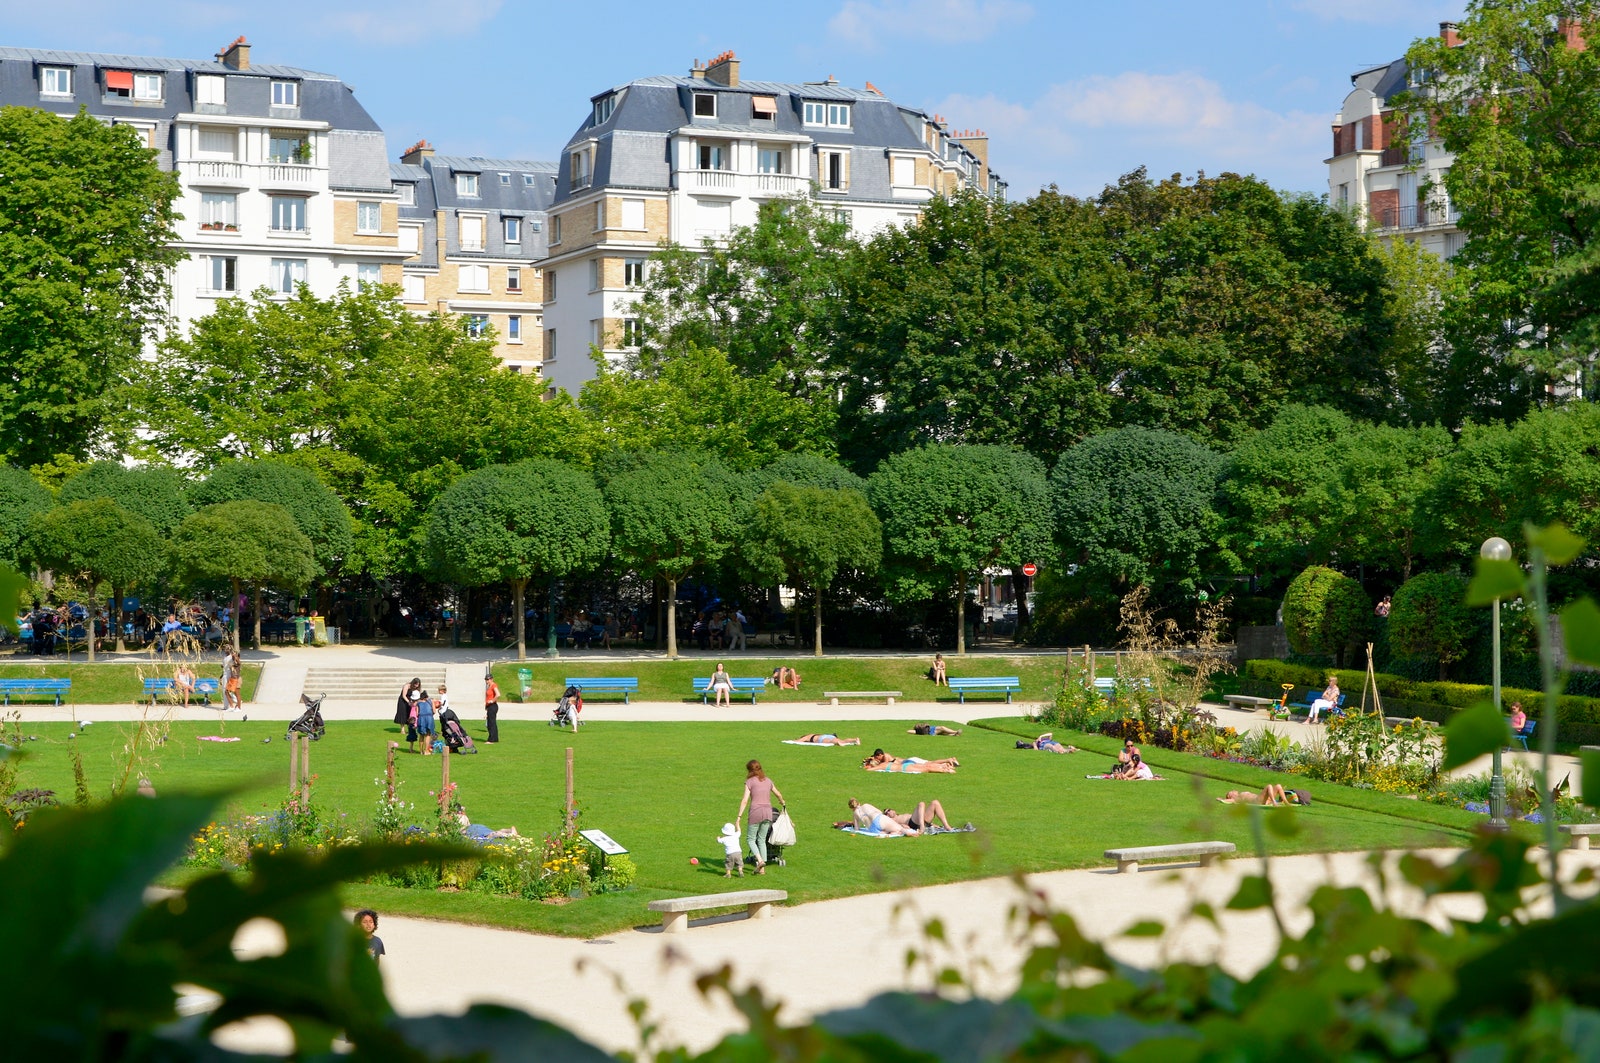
[{"left": 0, "top": 0, "right": 1462, "bottom": 199}]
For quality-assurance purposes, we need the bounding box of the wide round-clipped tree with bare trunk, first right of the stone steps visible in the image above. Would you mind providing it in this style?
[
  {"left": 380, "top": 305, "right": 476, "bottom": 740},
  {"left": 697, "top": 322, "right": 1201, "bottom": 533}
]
[{"left": 426, "top": 458, "right": 611, "bottom": 661}]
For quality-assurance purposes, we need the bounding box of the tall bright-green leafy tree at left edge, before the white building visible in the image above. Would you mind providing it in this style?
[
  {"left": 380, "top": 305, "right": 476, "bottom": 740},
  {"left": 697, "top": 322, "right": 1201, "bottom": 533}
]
[{"left": 0, "top": 107, "right": 182, "bottom": 466}]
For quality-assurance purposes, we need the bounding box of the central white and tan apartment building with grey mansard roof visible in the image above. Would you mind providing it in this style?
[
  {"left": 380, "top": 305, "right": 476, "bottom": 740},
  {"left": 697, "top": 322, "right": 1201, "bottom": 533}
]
[{"left": 542, "top": 51, "right": 1005, "bottom": 394}]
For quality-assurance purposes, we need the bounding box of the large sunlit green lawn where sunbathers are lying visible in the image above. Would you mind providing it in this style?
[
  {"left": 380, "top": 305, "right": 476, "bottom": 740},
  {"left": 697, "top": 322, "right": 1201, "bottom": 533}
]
[{"left": 0, "top": 714, "right": 1477, "bottom": 937}]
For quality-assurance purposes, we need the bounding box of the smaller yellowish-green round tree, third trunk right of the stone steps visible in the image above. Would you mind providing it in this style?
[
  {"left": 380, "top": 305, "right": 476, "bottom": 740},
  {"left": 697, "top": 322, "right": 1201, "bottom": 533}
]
[{"left": 744, "top": 480, "right": 883, "bottom": 656}]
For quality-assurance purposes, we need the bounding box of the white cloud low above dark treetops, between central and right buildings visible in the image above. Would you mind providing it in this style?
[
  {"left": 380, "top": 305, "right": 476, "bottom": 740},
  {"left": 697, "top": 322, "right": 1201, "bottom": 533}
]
[{"left": 933, "top": 70, "right": 1328, "bottom": 199}]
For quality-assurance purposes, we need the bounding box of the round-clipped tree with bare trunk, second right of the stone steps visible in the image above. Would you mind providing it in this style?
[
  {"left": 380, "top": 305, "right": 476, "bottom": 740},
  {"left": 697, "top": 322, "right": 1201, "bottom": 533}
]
[{"left": 605, "top": 450, "right": 741, "bottom": 656}]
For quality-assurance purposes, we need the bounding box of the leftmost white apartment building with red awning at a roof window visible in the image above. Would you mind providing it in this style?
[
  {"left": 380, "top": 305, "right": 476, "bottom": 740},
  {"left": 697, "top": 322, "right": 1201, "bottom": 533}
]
[{"left": 0, "top": 37, "right": 405, "bottom": 336}]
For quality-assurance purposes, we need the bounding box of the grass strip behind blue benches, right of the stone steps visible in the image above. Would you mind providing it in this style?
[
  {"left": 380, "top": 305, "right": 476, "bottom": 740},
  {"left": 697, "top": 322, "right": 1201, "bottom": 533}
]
[{"left": 494, "top": 653, "right": 1081, "bottom": 704}]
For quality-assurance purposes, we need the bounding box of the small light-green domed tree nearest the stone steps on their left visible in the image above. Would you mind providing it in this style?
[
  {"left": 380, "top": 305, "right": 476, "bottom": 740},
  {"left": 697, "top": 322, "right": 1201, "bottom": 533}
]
[{"left": 170, "top": 498, "right": 317, "bottom": 650}]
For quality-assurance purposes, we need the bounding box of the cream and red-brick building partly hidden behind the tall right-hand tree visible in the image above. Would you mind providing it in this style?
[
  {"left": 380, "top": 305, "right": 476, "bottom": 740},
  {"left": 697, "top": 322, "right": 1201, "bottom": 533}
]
[{"left": 1326, "top": 22, "right": 1466, "bottom": 258}]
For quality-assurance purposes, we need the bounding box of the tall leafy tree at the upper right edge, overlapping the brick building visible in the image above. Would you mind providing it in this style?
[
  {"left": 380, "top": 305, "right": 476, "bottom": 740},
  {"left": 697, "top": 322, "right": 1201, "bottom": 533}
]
[{"left": 1403, "top": 0, "right": 1600, "bottom": 400}]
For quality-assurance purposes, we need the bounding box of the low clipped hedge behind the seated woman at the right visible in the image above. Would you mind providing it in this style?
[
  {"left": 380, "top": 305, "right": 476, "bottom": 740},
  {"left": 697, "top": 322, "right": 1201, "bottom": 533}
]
[{"left": 1240, "top": 661, "right": 1600, "bottom": 744}]
